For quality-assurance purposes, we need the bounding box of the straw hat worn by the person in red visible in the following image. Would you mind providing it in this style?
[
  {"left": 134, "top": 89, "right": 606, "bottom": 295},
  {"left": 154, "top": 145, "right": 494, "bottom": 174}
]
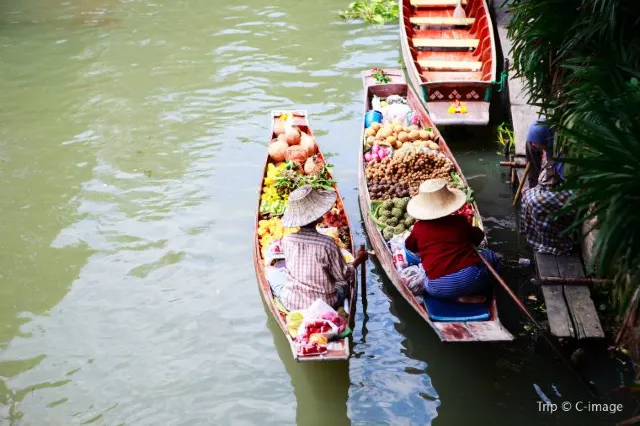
[{"left": 407, "top": 179, "right": 467, "bottom": 220}]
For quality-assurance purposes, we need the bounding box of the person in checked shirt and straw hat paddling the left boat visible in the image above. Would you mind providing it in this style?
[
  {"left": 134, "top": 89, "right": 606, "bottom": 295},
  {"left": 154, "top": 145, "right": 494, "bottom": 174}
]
[{"left": 279, "top": 185, "right": 367, "bottom": 311}]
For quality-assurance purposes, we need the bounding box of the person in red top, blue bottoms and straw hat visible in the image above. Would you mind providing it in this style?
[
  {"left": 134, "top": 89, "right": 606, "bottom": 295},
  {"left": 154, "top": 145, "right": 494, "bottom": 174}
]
[{"left": 405, "top": 179, "right": 498, "bottom": 303}]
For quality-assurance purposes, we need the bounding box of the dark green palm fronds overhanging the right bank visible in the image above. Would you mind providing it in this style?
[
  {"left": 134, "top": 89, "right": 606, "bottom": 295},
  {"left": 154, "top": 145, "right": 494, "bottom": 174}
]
[{"left": 508, "top": 0, "right": 640, "bottom": 311}]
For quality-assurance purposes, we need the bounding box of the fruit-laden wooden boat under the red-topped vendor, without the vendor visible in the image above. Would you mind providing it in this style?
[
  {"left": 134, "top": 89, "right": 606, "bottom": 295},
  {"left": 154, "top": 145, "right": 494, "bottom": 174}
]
[{"left": 358, "top": 70, "right": 513, "bottom": 342}]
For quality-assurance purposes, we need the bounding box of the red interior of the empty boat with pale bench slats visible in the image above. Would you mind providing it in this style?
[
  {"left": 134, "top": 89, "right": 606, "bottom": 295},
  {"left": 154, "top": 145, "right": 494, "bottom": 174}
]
[{"left": 402, "top": 0, "right": 495, "bottom": 82}]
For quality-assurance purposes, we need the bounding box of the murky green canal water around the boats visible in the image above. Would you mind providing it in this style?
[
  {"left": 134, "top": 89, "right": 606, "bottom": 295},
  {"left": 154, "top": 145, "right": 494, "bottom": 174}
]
[{"left": 0, "top": 0, "right": 635, "bottom": 426}]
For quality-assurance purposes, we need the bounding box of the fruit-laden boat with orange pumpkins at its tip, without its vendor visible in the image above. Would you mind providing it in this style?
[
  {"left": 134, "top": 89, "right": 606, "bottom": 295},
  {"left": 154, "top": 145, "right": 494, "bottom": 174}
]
[{"left": 254, "top": 111, "right": 357, "bottom": 361}]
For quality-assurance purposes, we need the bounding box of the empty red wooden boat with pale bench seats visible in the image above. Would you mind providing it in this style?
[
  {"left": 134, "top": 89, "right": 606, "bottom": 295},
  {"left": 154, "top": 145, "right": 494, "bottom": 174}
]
[{"left": 399, "top": 0, "right": 496, "bottom": 125}]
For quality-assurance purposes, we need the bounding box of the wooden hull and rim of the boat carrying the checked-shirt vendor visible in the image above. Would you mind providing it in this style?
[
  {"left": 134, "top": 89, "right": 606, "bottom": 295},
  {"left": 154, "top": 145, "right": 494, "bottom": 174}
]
[{"left": 254, "top": 111, "right": 357, "bottom": 361}]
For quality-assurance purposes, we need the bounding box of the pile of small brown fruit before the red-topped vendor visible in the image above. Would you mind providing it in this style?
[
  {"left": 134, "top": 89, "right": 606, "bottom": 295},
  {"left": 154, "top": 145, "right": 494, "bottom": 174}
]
[{"left": 365, "top": 151, "right": 455, "bottom": 200}]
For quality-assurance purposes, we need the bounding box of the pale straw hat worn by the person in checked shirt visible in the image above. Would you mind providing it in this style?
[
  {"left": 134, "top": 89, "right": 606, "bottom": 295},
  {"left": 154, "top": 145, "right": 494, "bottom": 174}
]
[{"left": 281, "top": 185, "right": 338, "bottom": 228}]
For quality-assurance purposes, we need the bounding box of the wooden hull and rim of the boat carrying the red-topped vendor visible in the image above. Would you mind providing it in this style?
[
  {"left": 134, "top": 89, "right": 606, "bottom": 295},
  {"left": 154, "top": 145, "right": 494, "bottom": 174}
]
[{"left": 358, "top": 70, "right": 513, "bottom": 342}]
